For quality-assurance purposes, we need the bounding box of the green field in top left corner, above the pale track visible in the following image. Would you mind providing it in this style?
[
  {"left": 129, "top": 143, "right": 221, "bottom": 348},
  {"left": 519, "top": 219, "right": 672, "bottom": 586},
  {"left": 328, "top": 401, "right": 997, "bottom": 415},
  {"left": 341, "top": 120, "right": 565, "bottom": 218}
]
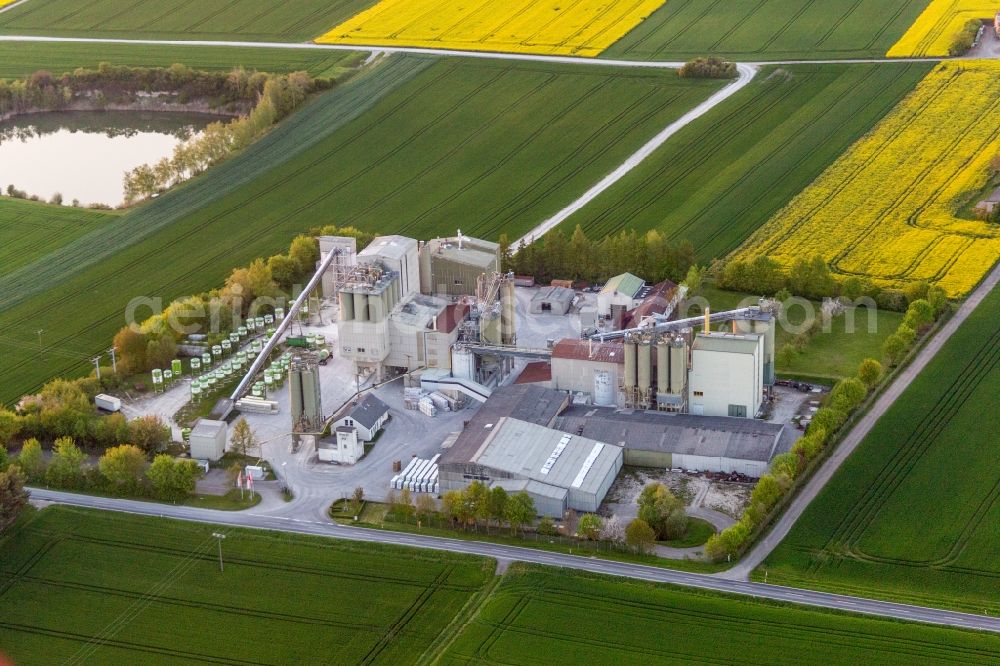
[{"left": 0, "top": 0, "right": 373, "bottom": 42}]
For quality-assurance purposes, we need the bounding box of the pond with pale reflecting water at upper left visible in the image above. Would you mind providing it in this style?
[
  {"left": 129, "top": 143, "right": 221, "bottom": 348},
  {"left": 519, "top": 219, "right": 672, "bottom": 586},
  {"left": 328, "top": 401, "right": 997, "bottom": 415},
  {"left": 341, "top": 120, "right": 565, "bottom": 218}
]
[{"left": 0, "top": 111, "right": 218, "bottom": 206}]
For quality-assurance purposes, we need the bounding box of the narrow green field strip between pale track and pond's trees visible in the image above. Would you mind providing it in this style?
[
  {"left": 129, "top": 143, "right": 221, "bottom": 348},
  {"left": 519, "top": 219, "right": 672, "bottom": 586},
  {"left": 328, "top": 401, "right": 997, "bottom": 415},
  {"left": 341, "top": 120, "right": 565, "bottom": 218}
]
[{"left": 0, "top": 41, "right": 366, "bottom": 79}]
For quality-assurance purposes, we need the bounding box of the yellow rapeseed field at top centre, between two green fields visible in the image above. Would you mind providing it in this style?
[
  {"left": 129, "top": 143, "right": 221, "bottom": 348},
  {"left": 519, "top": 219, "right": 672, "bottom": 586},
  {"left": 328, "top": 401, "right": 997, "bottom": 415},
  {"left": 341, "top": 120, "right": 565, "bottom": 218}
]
[{"left": 316, "top": 0, "right": 664, "bottom": 56}]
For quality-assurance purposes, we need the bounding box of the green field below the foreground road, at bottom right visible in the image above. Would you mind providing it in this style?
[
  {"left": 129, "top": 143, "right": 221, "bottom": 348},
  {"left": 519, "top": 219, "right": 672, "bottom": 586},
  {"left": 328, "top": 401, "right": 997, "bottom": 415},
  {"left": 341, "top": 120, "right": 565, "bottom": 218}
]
[{"left": 440, "top": 566, "right": 1000, "bottom": 666}]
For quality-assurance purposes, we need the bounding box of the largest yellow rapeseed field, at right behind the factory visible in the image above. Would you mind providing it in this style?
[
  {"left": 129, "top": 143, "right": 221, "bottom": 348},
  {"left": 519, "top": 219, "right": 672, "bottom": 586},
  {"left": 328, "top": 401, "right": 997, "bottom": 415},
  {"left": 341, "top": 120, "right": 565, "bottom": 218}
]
[{"left": 737, "top": 61, "right": 1000, "bottom": 297}]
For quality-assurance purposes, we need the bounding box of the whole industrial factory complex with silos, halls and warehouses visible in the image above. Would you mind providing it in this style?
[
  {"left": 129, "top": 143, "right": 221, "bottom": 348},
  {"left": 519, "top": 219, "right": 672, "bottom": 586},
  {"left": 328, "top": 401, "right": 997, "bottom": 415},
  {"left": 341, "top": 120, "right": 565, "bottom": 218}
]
[{"left": 180, "top": 232, "right": 791, "bottom": 517}]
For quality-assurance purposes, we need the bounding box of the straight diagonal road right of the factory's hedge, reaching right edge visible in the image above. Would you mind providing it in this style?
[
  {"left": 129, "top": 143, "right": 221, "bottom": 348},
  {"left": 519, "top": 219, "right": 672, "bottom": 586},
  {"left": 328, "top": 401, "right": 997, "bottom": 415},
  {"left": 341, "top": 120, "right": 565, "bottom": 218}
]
[{"left": 718, "top": 264, "right": 1000, "bottom": 580}]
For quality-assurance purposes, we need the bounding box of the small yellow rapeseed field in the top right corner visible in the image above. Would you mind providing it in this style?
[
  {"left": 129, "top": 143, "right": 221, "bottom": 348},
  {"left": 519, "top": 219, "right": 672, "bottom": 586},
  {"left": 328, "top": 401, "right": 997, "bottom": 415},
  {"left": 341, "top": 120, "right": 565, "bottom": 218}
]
[{"left": 886, "top": 0, "right": 1000, "bottom": 58}]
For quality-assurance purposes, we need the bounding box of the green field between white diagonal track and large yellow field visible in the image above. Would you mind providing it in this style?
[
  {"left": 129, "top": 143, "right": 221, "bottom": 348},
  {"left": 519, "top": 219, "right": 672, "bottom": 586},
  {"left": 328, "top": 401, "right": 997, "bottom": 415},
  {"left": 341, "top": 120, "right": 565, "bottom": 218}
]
[{"left": 563, "top": 64, "right": 931, "bottom": 262}]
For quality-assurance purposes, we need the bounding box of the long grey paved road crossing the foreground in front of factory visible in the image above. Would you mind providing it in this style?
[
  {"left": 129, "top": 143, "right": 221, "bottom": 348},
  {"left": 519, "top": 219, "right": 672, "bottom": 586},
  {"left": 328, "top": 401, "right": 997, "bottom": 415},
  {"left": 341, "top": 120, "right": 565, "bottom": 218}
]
[{"left": 31, "top": 488, "right": 1000, "bottom": 633}]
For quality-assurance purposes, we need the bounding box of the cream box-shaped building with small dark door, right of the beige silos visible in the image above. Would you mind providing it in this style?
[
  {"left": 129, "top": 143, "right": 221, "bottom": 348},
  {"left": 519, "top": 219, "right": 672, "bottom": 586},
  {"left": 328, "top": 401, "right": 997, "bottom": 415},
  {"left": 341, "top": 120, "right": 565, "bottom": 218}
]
[{"left": 688, "top": 333, "right": 764, "bottom": 418}]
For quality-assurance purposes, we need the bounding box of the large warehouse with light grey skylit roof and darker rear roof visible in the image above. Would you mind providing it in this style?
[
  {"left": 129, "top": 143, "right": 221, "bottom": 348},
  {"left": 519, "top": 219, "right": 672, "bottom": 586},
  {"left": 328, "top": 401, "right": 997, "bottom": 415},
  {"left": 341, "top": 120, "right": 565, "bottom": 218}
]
[{"left": 438, "top": 385, "right": 623, "bottom": 517}]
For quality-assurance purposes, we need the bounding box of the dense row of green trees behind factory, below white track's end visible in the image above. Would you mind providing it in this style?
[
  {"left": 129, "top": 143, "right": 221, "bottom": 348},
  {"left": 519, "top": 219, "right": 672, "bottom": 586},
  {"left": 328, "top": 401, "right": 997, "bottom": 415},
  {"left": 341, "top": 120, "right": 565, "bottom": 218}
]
[{"left": 500, "top": 225, "right": 695, "bottom": 284}]
